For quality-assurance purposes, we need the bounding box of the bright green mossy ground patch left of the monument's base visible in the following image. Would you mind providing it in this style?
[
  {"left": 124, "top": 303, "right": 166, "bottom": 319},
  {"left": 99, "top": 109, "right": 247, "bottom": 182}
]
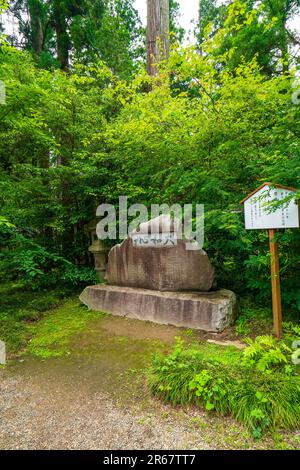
[{"left": 0, "top": 283, "right": 106, "bottom": 358}]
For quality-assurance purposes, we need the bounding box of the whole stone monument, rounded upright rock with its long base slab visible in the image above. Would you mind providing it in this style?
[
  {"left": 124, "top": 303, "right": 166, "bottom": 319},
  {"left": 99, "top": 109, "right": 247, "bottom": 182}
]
[{"left": 80, "top": 216, "right": 237, "bottom": 332}]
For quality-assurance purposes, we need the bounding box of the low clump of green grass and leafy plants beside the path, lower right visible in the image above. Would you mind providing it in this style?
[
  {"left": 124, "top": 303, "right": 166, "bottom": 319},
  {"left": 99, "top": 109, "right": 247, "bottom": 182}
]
[{"left": 149, "top": 341, "right": 300, "bottom": 438}]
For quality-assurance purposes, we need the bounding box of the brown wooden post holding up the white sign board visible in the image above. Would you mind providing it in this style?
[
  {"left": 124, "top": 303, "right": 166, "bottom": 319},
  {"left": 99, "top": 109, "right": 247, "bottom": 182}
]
[{"left": 269, "top": 229, "right": 282, "bottom": 338}]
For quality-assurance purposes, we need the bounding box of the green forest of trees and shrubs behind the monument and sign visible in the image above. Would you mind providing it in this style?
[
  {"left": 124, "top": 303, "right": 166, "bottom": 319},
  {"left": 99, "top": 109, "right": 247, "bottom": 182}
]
[{"left": 0, "top": 0, "right": 300, "bottom": 314}]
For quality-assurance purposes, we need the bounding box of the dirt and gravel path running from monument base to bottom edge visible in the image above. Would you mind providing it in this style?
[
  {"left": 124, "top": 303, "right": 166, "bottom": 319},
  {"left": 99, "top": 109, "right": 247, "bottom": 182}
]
[{"left": 0, "top": 317, "right": 296, "bottom": 450}]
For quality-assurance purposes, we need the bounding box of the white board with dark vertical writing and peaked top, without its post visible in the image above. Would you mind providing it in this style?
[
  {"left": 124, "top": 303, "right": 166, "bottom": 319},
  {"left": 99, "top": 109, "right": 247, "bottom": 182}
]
[{"left": 244, "top": 184, "right": 299, "bottom": 230}]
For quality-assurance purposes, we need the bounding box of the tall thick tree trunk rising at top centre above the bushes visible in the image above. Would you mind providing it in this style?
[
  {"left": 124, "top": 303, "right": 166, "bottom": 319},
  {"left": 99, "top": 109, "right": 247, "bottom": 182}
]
[{"left": 147, "top": 0, "right": 170, "bottom": 76}]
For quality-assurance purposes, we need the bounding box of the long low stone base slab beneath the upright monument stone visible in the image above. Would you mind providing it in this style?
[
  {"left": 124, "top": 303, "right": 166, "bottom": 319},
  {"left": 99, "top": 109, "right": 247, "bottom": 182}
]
[{"left": 80, "top": 285, "right": 237, "bottom": 332}]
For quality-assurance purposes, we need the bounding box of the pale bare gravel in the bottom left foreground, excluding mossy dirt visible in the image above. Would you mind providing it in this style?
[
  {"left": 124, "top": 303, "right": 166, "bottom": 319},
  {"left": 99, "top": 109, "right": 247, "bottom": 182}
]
[{"left": 0, "top": 364, "right": 209, "bottom": 450}]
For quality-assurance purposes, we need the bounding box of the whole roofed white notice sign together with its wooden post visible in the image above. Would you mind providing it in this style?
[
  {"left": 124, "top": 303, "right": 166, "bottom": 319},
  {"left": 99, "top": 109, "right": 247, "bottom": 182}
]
[{"left": 241, "top": 183, "right": 300, "bottom": 338}]
